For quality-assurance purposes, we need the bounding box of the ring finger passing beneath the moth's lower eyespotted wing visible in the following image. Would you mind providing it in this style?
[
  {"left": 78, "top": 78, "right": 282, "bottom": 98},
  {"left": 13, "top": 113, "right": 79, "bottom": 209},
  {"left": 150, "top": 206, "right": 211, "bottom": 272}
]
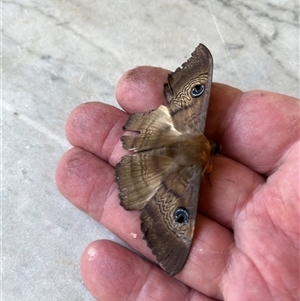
[{"left": 56, "top": 148, "right": 233, "bottom": 298}]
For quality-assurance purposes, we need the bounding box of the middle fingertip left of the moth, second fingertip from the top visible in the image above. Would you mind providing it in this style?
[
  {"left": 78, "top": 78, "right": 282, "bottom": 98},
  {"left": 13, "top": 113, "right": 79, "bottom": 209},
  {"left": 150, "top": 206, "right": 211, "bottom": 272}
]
[{"left": 66, "top": 102, "right": 128, "bottom": 166}]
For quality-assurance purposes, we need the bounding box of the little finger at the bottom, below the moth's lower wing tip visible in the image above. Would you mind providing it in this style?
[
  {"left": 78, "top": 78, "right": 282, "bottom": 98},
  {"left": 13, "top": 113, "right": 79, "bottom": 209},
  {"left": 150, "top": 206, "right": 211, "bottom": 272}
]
[{"left": 80, "top": 240, "right": 217, "bottom": 301}]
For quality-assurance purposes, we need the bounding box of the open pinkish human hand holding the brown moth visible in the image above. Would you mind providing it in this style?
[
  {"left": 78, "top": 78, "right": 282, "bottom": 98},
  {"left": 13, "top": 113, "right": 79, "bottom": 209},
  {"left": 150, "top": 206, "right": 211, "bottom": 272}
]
[{"left": 56, "top": 67, "right": 300, "bottom": 301}]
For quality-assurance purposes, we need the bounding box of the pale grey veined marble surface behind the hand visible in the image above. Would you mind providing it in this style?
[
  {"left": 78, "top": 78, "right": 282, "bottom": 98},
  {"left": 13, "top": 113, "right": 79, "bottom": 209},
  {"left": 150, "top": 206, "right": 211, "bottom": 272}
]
[{"left": 2, "top": 0, "right": 299, "bottom": 301}]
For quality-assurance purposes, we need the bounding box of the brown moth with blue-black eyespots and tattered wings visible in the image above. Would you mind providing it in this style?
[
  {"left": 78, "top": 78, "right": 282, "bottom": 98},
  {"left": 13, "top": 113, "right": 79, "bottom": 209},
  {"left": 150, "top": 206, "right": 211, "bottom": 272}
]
[{"left": 116, "top": 44, "right": 215, "bottom": 276}]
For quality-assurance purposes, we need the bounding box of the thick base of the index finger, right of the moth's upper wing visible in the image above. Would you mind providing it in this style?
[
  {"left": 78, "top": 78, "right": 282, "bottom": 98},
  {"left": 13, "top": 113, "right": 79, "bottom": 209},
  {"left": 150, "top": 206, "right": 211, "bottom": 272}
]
[{"left": 206, "top": 84, "right": 300, "bottom": 175}]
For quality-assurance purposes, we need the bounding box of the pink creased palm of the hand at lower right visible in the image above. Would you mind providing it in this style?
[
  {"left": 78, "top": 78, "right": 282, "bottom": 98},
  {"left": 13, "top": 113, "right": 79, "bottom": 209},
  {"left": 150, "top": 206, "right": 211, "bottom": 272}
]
[{"left": 223, "top": 170, "right": 299, "bottom": 300}]
